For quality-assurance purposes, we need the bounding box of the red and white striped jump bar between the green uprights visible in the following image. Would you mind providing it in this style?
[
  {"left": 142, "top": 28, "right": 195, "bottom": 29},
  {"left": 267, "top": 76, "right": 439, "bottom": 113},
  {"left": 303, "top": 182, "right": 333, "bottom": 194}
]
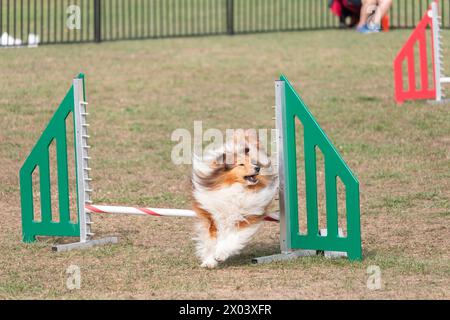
[{"left": 85, "top": 204, "right": 280, "bottom": 222}]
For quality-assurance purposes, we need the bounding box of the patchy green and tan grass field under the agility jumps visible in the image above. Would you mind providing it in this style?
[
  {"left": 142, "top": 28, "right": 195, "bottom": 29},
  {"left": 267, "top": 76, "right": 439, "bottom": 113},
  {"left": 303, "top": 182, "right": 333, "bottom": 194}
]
[{"left": 0, "top": 31, "right": 450, "bottom": 299}]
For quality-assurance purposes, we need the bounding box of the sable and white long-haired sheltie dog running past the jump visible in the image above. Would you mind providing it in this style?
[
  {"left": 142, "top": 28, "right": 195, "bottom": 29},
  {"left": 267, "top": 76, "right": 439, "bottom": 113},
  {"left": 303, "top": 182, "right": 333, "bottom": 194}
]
[{"left": 192, "top": 130, "right": 277, "bottom": 268}]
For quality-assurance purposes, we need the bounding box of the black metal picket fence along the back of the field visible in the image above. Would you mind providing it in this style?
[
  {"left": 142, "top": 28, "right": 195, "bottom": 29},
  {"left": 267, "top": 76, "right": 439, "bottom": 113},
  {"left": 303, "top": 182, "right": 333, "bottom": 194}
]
[{"left": 0, "top": 0, "right": 450, "bottom": 45}]
